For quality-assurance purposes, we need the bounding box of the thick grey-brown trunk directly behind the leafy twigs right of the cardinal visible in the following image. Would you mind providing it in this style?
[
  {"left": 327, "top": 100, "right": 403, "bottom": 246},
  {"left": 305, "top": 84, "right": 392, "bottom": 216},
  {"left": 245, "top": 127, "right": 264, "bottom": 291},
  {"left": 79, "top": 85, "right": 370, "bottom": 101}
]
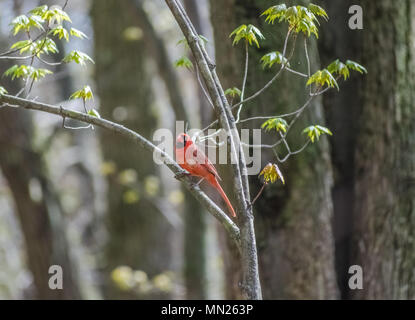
[{"left": 210, "top": 0, "right": 337, "bottom": 299}]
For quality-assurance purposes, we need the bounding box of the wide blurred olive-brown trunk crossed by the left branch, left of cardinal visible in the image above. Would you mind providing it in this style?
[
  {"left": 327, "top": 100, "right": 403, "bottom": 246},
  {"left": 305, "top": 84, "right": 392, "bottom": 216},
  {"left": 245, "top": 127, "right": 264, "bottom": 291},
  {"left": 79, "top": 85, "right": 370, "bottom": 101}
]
[{"left": 92, "top": 0, "right": 173, "bottom": 298}]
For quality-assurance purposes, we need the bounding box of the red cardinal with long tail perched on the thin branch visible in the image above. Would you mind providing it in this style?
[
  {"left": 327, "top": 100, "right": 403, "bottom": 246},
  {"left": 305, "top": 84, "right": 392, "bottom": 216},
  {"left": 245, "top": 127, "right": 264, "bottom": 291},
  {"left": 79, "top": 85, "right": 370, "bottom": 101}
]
[{"left": 176, "top": 133, "right": 236, "bottom": 217}]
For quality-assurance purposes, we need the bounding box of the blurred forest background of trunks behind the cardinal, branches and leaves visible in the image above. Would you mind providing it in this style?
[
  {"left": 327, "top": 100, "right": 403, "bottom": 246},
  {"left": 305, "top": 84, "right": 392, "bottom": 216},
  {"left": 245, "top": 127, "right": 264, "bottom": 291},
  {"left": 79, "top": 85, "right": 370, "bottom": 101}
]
[{"left": 0, "top": 0, "right": 415, "bottom": 299}]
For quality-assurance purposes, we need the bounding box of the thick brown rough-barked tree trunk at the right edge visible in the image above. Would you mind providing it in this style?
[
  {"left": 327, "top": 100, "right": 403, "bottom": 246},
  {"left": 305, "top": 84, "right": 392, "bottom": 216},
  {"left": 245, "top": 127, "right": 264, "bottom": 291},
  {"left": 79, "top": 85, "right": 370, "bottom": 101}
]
[{"left": 351, "top": 0, "right": 415, "bottom": 299}]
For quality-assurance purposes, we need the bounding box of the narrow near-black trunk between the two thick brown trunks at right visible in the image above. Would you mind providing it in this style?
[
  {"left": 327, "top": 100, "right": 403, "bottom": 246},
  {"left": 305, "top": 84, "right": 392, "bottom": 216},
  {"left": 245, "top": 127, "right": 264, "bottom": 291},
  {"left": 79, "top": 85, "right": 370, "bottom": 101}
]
[{"left": 318, "top": 0, "right": 367, "bottom": 299}]
